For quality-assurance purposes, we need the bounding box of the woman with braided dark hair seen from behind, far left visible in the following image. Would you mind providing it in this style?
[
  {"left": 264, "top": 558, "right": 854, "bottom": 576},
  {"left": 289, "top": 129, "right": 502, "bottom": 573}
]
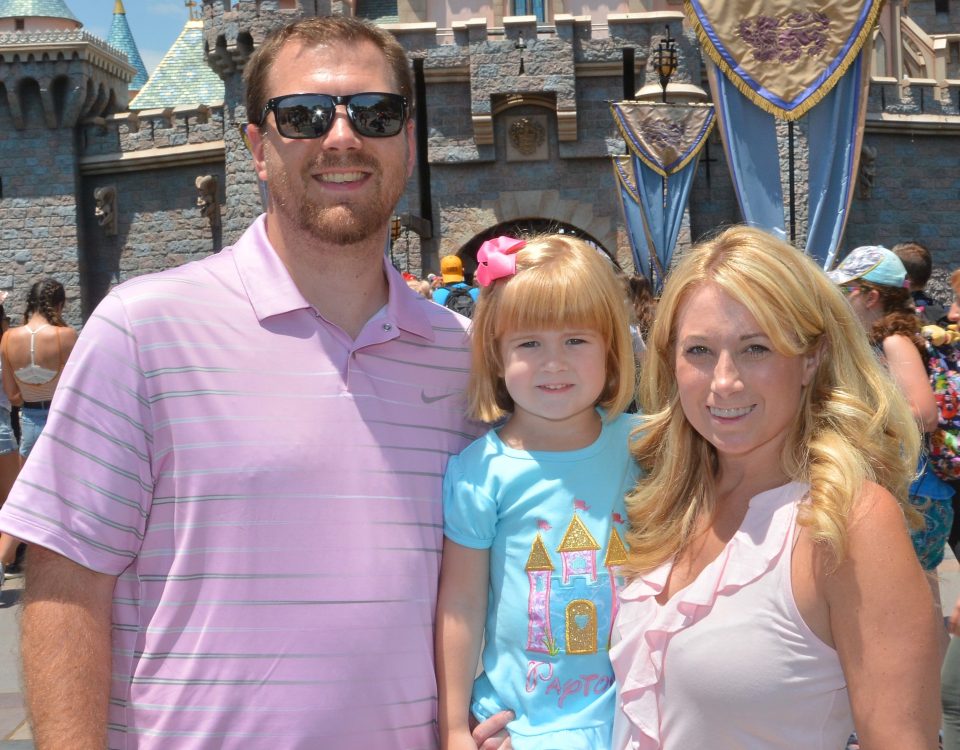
[{"left": 0, "top": 279, "right": 77, "bottom": 580}]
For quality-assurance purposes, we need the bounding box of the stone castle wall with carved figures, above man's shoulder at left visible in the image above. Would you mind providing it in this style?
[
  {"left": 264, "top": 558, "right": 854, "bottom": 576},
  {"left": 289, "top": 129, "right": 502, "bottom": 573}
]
[{"left": 79, "top": 107, "right": 229, "bottom": 318}]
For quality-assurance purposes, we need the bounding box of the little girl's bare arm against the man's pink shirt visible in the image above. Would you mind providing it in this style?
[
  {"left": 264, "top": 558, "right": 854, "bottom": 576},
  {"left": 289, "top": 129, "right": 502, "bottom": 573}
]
[{"left": 436, "top": 538, "right": 490, "bottom": 750}]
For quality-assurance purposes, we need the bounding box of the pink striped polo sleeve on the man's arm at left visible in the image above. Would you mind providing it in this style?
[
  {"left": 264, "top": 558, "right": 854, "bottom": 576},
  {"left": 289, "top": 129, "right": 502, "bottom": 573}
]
[{"left": 0, "top": 294, "right": 153, "bottom": 575}]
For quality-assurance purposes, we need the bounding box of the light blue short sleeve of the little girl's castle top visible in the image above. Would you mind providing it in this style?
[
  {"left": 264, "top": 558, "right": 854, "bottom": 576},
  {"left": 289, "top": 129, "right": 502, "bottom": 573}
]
[{"left": 443, "top": 456, "right": 497, "bottom": 549}]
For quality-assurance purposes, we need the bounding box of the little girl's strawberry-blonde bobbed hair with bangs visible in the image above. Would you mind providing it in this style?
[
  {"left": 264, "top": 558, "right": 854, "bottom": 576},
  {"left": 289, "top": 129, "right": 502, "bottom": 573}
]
[{"left": 468, "top": 234, "right": 636, "bottom": 422}]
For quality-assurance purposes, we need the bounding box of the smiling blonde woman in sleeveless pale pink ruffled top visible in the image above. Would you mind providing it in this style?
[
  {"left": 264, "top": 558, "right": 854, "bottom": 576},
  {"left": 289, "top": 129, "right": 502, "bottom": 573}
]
[{"left": 611, "top": 227, "right": 940, "bottom": 750}]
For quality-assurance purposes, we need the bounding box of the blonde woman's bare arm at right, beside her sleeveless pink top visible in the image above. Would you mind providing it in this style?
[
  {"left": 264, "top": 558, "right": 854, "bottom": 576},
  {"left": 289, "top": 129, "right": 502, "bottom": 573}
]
[{"left": 819, "top": 483, "right": 943, "bottom": 750}]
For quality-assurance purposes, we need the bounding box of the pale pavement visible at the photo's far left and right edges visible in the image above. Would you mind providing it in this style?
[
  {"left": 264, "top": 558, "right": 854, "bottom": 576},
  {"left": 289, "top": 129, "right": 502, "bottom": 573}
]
[{"left": 0, "top": 548, "right": 960, "bottom": 750}]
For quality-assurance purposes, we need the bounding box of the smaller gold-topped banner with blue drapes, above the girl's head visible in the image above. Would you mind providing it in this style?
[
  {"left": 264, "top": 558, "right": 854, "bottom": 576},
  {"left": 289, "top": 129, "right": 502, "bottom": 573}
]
[{"left": 610, "top": 102, "right": 714, "bottom": 293}]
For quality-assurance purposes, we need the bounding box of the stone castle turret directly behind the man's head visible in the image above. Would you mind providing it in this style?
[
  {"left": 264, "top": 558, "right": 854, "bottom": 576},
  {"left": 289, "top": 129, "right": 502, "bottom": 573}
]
[{"left": 203, "top": 0, "right": 345, "bottom": 244}]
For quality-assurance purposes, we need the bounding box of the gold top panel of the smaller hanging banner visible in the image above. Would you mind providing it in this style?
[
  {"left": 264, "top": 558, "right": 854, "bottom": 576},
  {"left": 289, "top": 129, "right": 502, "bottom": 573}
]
[{"left": 610, "top": 102, "right": 714, "bottom": 177}]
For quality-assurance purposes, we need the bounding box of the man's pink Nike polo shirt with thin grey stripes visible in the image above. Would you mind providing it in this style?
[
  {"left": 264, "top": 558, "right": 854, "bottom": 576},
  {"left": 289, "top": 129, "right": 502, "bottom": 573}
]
[{"left": 0, "top": 217, "right": 480, "bottom": 750}]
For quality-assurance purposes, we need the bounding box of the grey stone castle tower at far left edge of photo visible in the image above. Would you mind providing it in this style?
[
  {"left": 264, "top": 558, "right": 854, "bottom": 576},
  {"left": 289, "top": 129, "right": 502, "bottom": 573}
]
[{"left": 0, "top": 0, "right": 136, "bottom": 322}]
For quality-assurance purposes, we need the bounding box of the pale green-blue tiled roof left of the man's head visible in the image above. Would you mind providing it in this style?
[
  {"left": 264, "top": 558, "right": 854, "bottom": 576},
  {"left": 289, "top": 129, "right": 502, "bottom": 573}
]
[{"left": 130, "top": 20, "right": 223, "bottom": 109}]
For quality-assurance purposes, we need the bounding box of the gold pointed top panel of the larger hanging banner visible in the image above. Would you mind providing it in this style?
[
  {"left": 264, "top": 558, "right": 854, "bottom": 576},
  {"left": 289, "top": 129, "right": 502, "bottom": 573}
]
[{"left": 684, "top": 0, "right": 883, "bottom": 120}]
